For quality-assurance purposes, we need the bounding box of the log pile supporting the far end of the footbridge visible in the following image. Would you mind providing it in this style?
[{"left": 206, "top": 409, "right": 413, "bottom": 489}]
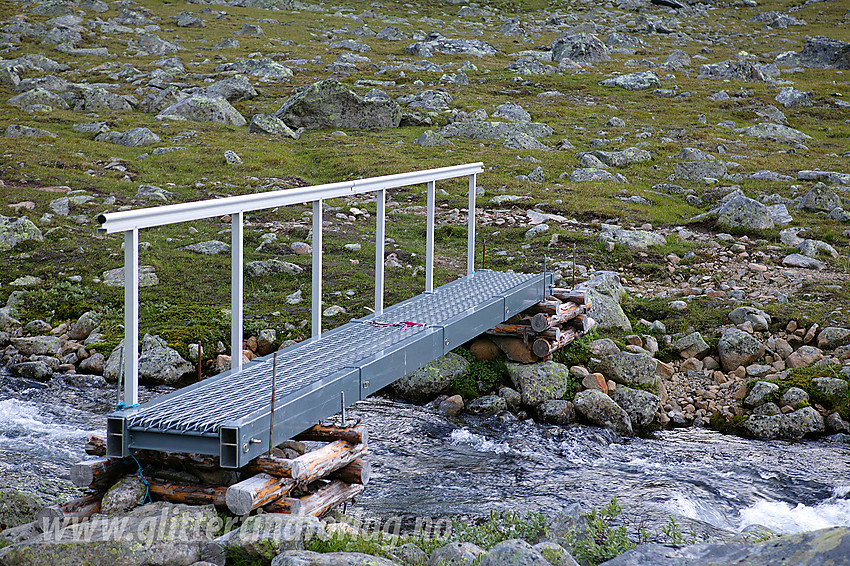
[{"left": 486, "top": 288, "right": 596, "bottom": 360}]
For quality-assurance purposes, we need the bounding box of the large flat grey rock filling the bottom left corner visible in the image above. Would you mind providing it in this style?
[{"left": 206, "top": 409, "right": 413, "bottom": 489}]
[{"left": 0, "top": 502, "right": 224, "bottom": 566}]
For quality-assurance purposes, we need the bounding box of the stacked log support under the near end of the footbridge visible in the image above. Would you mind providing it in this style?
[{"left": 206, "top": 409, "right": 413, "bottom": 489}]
[{"left": 59, "top": 425, "right": 371, "bottom": 524}]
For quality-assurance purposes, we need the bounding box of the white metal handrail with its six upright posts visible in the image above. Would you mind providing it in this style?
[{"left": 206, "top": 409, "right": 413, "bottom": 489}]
[{"left": 97, "top": 162, "right": 484, "bottom": 407}]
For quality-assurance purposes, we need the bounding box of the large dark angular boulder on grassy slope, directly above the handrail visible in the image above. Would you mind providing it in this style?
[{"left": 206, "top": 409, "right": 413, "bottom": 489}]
[{"left": 275, "top": 79, "right": 402, "bottom": 130}]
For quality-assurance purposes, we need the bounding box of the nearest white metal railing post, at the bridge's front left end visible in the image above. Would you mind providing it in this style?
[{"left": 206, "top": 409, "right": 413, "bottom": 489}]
[{"left": 123, "top": 228, "right": 139, "bottom": 407}]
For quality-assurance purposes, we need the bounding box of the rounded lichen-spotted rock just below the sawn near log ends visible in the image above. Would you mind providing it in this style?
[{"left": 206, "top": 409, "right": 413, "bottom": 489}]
[{"left": 227, "top": 513, "right": 326, "bottom": 560}]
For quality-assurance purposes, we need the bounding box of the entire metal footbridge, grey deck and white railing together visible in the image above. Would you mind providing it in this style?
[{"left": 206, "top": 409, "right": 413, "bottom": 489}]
[{"left": 99, "top": 163, "right": 552, "bottom": 468}]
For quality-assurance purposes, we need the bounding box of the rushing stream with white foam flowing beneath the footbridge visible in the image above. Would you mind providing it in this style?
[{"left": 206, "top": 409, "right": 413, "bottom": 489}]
[{"left": 0, "top": 373, "right": 850, "bottom": 535}]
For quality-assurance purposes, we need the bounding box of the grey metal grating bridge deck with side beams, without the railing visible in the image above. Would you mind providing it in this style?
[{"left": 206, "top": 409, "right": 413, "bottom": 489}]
[{"left": 107, "top": 270, "right": 551, "bottom": 468}]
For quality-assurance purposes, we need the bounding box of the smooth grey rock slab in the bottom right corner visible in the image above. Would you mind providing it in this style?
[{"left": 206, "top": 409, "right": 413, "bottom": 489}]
[{"left": 600, "top": 527, "right": 850, "bottom": 566}]
